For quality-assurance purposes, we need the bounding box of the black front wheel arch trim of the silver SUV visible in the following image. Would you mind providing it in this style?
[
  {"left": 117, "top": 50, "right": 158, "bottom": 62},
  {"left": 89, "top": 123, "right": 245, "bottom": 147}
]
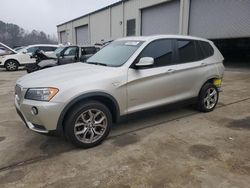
[{"left": 57, "top": 92, "right": 120, "bottom": 133}]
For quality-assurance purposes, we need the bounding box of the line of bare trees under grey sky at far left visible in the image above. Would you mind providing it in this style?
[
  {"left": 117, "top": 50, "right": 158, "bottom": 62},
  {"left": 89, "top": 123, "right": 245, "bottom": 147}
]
[{"left": 0, "top": 20, "right": 57, "bottom": 48}]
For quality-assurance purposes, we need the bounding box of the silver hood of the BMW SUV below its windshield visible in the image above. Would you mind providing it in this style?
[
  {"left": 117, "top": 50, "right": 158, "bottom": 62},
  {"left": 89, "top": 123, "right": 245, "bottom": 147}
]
[{"left": 17, "top": 63, "right": 115, "bottom": 88}]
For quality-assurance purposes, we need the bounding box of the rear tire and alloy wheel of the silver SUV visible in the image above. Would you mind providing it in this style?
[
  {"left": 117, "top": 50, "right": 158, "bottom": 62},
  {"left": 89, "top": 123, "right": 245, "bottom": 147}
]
[{"left": 197, "top": 83, "right": 219, "bottom": 112}]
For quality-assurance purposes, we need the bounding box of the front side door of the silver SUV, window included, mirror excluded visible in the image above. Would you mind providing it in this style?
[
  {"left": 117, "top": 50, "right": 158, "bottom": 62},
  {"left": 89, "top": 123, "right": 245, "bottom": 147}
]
[{"left": 127, "top": 39, "right": 176, "bottom": 113}]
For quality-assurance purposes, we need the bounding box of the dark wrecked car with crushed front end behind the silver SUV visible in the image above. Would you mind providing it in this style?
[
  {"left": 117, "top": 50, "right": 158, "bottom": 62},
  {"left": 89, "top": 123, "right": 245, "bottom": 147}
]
[{"left": 25, "top": 46, "right": 100, "bottom": 73}]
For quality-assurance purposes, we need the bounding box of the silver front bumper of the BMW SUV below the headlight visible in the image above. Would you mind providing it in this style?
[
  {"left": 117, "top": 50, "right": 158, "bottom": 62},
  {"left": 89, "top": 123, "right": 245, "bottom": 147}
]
[{"left": 15, "top": 96, "right": 63, "bottom": 133}]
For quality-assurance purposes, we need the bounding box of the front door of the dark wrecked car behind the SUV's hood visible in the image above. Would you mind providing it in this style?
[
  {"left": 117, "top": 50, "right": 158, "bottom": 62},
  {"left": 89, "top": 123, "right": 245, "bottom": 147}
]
[{"left": 58, "top": 46, "right": 79, "bottom": 65}]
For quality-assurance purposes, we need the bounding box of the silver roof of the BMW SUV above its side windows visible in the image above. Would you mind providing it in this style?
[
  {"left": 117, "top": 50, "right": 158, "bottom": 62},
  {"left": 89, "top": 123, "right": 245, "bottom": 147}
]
[{"left": 117, "top": 35, "right": 209, "bottom": 42}]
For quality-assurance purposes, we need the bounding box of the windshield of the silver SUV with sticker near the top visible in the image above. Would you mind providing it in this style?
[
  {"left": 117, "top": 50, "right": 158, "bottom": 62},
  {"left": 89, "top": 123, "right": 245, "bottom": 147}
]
[{"left": 87, "top": 40, "right": 144, "bottom": 67}]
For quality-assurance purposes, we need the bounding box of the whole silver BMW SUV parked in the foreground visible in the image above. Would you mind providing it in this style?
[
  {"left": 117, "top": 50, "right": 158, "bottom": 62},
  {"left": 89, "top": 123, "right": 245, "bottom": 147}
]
[{"left": 15, "top": 35, "right": 224, "bottom": 148}]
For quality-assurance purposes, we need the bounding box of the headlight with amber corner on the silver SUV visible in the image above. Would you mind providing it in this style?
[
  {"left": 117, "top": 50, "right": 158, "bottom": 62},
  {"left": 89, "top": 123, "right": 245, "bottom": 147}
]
[{"left": 24, "top": 87, "right": 59, "bottom": 101}]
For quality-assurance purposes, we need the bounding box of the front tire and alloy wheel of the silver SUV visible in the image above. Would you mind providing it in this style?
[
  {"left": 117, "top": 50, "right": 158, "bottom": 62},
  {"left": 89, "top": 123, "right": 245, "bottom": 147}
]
[{"left": 64, "top": 101, "right": 112, "bottom": 148}]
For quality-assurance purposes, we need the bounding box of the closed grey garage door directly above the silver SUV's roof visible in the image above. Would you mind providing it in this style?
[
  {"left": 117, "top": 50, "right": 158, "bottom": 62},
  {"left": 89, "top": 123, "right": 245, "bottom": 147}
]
[{"left": 141, "top": 0, "right": 180, "bottom": 35}]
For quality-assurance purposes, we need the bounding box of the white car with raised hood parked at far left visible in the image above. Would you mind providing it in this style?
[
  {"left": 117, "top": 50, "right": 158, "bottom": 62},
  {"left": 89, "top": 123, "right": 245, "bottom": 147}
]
[{"left": 0, "top": 43, "right": 58, "bottom": 71}]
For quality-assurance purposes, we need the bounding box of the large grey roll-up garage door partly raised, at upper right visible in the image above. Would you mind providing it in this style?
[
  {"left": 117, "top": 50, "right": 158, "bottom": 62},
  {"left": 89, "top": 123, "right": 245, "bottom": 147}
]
[{"left": 189, "top": 0, "right": 250, "bottom": 39}]
